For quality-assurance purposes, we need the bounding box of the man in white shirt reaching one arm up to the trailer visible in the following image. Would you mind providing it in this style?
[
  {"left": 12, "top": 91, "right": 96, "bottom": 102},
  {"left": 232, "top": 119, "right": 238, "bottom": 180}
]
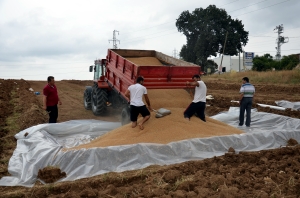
[{"left": 184, "top": 74, "right": 207, "bottom": 122}]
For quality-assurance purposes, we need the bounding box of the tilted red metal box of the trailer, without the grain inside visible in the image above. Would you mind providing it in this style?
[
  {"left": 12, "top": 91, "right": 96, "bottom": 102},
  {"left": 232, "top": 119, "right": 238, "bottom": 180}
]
[{"left": 105, "top": 49, "right": 201, "bottom": 96}]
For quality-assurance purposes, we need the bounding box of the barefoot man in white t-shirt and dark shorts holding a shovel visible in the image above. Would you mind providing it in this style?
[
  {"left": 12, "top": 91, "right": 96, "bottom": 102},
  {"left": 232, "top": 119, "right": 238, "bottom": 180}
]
[{"left": 125, "top": 76, "right": 151, "bottom": 130}]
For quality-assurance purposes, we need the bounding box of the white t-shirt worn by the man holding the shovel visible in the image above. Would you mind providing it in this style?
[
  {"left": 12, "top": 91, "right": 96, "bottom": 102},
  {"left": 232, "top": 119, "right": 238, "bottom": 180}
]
[{"left": 128, "top": 83, "right": 147, "bottom": 107}]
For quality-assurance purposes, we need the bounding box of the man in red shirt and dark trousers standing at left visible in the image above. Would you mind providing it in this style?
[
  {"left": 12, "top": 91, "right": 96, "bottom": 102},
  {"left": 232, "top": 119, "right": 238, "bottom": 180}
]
[{"left": 43, "top": 76, "right": 62, "bottom": 123}]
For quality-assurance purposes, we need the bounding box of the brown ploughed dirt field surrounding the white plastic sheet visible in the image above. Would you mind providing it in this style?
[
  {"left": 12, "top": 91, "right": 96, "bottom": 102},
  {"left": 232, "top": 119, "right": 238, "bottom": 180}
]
[{"left": 0, "top": 78, "right": 300, "bottom": 198}]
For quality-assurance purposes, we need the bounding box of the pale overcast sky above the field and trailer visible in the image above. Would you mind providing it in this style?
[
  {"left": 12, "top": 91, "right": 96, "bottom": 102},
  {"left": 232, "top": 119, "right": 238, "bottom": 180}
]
[{"left": 0, "top": 0, "right": 300, "bottom": 80}]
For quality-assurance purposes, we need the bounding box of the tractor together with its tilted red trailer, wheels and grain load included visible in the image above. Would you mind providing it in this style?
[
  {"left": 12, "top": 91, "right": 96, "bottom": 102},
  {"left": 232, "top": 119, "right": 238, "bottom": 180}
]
[{"left": 84, "top": 49, "right": 202, "bottom": 124}]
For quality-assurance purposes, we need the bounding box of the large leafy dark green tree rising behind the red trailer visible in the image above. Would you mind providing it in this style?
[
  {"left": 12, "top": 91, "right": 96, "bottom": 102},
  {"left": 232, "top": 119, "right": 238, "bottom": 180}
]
[{"left": 176, "top": 5, "right": 249, "bottom": 66}]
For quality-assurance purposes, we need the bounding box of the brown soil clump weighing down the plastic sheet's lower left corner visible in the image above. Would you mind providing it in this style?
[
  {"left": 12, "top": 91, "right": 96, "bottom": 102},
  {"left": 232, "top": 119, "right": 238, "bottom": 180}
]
[{"left": 38, "top": 166, "right": 67, "bottom": 183}]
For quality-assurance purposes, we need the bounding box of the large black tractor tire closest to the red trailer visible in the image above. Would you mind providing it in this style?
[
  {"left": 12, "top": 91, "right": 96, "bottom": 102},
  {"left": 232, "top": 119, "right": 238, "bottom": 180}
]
[{"left": 92, "top": 85, "right": 108, "bottom": 116}]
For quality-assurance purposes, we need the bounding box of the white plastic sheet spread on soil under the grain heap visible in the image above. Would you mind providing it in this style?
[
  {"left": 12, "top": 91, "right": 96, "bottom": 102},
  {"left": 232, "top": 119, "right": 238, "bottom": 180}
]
[{"left": 0, "top": 107, "right": 300, "bottom": 187}]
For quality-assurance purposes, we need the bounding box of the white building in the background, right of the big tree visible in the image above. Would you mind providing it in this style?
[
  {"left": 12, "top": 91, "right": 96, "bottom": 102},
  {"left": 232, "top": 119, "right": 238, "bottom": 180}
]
[{"left": 212, "top": 55, "right": 252, "bottom": 72}]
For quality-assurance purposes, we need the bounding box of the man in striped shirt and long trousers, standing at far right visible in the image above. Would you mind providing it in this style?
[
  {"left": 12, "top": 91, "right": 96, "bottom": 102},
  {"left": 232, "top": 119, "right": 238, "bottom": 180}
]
[{"left": 239, "top": 77, "right": 255, "bottom": 127}]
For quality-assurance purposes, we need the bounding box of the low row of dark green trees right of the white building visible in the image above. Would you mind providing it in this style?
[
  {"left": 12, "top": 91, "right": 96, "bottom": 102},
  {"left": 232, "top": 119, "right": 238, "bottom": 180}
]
[{"left": 252, "top": 54, "right": 299, "bottom": 71}]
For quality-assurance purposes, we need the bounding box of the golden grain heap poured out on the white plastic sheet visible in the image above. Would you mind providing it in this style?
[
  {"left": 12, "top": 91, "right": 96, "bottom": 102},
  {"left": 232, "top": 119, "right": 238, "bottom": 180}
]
[{"left": 73, "top": 89, "right": 243, "bottom": 149}]
